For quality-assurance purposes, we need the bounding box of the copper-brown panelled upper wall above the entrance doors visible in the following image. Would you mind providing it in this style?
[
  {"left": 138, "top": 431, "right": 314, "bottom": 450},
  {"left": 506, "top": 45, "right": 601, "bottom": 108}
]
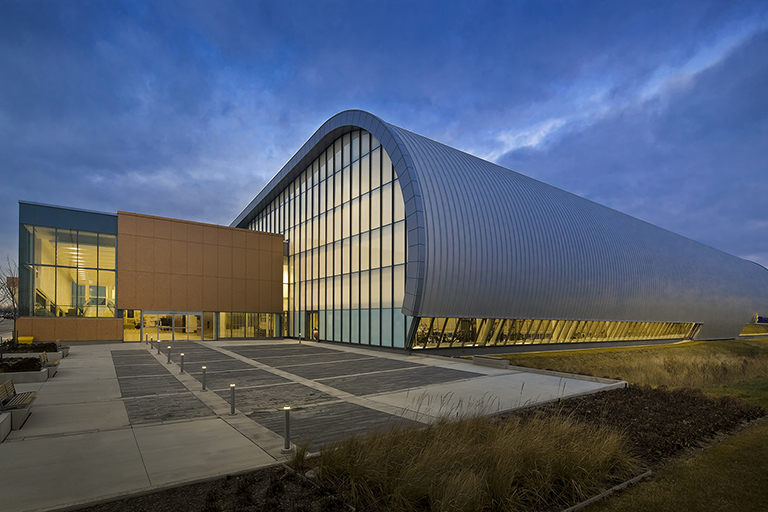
[{"left": 118, "top": 212, "right": 282, "bottom": 313}]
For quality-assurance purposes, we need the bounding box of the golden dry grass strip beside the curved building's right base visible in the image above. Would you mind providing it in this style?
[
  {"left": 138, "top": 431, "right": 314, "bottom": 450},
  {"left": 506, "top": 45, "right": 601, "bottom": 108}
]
[{"left": 500, "top": 338, "right": 768, "bottom": 388}]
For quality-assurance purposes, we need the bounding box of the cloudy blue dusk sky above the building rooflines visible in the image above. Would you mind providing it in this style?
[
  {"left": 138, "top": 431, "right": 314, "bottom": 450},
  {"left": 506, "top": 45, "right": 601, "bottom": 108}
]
[{"left": 0, "top": 0, "right": 768, "bottom": 266}]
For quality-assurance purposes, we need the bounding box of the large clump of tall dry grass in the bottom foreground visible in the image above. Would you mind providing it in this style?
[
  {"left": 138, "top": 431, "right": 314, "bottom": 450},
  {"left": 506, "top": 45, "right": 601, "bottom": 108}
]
[{"left": 317, "top": 417, "right": 636, "bottom": 512}]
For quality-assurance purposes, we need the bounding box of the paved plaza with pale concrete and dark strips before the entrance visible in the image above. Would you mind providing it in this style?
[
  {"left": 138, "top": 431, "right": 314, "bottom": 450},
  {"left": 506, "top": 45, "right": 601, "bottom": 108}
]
[{"left": 0, "top": 341, "right": 624, "bottom": 512}]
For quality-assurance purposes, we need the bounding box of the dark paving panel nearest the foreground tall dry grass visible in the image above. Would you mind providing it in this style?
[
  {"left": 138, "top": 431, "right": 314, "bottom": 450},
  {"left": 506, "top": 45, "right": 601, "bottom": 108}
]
[{"left": 248, "top": 402, "right": 422, "bottom": 451}]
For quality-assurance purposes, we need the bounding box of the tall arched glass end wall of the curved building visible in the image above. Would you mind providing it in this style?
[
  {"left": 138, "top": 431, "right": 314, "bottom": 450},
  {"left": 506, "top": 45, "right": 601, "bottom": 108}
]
[{"left": 249, "top": 130, "right": 411, "bottom": 348}]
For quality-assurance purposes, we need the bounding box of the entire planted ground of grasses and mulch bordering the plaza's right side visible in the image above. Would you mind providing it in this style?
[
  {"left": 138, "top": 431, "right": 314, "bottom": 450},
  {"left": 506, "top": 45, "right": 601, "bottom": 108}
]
[{"left": 72, "top": 339, "right": 768, "bottom": 512}]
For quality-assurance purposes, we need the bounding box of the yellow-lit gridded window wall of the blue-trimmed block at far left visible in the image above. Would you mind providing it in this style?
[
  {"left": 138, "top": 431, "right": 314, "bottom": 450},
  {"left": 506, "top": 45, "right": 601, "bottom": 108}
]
[{"left": 20, "top": 224, "right": 117, "bottom": 318}]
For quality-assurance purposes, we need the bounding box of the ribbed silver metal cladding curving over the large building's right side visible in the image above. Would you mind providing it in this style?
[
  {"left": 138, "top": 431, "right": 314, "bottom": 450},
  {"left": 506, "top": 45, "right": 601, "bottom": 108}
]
[{"left": 390, "top": 125, "right": 768, "bottom": 338}]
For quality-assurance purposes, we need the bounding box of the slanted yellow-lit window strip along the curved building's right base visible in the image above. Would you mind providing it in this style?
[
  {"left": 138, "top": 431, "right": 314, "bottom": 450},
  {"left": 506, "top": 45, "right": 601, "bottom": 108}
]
[{"left": 414, "top": 318, "right": 699, "bottom": 348}]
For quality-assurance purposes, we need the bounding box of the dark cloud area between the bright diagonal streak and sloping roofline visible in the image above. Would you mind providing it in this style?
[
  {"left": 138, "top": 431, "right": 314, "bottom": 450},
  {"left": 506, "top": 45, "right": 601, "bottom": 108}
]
[{"left": 500, "top": 31, "right": 768, "bottom": 264}]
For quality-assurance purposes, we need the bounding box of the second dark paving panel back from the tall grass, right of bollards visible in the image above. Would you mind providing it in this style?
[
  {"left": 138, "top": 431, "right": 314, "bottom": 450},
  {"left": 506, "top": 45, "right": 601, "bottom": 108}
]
[{"left": 216, "top": 382, "right": 336, "bottom": 414}]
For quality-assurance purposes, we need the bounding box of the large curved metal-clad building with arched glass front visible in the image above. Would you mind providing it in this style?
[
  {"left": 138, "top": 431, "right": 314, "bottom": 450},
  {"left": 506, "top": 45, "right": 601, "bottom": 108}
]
[{"left": 232, "top": 110, "right": 768, "bottom": 348}]
